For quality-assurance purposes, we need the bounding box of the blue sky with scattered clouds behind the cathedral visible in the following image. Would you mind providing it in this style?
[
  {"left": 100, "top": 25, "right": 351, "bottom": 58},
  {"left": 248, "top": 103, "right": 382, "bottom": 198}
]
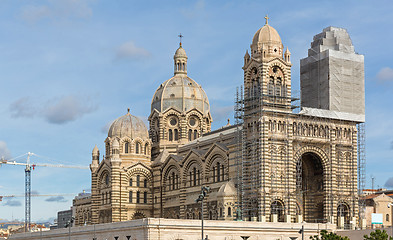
[{"left": 0, "top": 0, "right": 393, "bottom": 221}]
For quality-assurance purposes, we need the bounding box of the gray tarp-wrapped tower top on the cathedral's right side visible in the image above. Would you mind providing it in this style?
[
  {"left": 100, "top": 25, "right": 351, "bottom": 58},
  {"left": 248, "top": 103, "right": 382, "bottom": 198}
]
[{"left": 300, "top": 27, "right": 365, "bottom": 120}]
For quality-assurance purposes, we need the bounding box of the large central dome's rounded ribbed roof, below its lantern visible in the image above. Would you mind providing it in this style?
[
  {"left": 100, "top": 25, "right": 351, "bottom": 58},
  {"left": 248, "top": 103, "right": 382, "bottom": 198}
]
[{"left": 151, "top": 74, "right": 210, "bottom": 115}]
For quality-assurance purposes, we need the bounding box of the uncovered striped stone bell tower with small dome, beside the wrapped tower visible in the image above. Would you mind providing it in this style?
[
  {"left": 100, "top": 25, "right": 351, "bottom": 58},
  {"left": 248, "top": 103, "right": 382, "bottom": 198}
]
[{"left": 243, "top": 16, "right": 292, "bottom": 116}]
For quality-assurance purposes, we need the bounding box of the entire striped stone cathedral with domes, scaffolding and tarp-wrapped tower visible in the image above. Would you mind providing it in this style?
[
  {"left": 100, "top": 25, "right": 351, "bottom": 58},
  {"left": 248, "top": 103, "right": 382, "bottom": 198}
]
[{"left": 73, "top": 17, "right": 365, "bottom": 229}]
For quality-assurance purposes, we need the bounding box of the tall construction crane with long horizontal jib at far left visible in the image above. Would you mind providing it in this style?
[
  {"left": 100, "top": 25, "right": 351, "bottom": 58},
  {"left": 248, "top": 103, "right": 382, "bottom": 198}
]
[{"left": 0, "top": 152, "right": 89, "bottom": 232}]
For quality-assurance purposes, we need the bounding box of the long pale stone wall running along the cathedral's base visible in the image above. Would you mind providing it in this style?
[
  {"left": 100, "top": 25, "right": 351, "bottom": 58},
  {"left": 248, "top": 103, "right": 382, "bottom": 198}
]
[{"left": 10, "top": 218, "right": 335, "bottom": 240}]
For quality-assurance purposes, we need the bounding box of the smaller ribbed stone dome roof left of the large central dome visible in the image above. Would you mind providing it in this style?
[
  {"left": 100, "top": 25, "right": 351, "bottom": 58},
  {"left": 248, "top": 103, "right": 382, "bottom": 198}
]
[{"left": 108, "top": 112, "right": 149, "bottom": 139}]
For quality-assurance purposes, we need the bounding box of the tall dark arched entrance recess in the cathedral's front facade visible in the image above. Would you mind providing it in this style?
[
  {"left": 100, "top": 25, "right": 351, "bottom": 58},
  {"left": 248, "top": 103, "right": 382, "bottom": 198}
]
[{"left": 296, "top": 152, "right": 327, "bottom": 223}]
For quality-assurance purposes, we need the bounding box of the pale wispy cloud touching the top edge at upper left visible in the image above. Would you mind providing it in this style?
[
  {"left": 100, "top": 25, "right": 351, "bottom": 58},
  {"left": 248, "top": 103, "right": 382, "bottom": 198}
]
[{"left": 20, "top": 0, "right": 93, "bottom": 23}]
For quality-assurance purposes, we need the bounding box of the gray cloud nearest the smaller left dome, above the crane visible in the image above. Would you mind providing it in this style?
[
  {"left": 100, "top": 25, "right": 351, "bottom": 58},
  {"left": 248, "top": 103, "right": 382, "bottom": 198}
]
[{"left": 43, "top": 96, "right": 97, "bottom": 124}]
